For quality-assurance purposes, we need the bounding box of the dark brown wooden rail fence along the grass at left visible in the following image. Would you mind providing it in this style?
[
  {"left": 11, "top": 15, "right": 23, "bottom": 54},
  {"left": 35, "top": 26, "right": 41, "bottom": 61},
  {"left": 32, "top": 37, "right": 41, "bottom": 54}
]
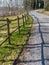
[{"left": 0, "top": 15, "right": 28, "bottom": 46}]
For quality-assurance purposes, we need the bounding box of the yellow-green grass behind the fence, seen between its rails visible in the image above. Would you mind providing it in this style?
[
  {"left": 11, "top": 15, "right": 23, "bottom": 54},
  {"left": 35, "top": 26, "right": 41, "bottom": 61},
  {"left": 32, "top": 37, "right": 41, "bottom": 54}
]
[{"left": 0, "top": 13, "right": 26, "bottom": 43}]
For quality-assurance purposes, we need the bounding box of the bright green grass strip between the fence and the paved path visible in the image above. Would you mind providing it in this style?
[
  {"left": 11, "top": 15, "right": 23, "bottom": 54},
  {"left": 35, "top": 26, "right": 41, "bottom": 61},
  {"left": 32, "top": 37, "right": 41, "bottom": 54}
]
[{"left": 0, "top": 17, "right": 32, "bottom": 65}]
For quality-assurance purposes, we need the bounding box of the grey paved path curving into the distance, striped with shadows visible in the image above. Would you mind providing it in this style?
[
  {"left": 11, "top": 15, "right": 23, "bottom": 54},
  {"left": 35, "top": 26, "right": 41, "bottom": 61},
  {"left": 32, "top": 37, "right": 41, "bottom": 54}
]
[{"left": 17, "top": 11, "right": 49, "bottom": 65}]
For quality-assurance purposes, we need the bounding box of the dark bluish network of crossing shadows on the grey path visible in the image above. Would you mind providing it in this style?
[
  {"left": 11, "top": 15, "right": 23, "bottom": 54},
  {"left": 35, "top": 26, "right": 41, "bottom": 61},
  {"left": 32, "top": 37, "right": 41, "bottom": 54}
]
[{"left": 13, "top": 17, "right": 49, "bottom": 65}]
